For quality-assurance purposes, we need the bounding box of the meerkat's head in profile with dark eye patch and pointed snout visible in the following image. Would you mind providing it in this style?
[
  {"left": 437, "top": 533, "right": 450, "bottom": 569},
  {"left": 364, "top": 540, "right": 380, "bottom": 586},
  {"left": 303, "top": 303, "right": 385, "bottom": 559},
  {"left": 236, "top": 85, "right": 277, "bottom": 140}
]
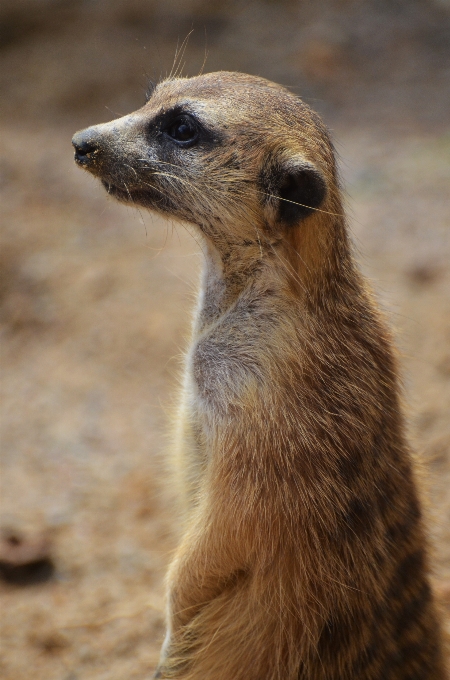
[{"left": 73, "top": 72, "right": 334, "bottom": 250}]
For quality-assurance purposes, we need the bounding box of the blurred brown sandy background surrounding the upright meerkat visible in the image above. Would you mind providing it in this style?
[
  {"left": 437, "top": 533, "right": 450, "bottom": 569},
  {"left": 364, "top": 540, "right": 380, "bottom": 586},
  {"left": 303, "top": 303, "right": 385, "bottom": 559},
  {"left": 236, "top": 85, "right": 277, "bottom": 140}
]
[{"left": 0, "top": 0, "right": 450, "bottom": 680}]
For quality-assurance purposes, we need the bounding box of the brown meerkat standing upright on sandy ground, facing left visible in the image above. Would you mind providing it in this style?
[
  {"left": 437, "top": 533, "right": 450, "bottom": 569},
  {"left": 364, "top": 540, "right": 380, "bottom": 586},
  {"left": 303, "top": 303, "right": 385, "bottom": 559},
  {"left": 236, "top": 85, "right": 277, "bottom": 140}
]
[{"left": 73, "top": 72, "right": 446, "bottom": 680}]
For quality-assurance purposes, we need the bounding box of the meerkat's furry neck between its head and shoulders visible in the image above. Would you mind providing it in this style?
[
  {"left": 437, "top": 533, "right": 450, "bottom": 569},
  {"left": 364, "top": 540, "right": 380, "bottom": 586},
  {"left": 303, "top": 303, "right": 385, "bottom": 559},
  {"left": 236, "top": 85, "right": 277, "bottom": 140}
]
[{"left": 196, "top": 210, "right": 360, "bottom": 333}]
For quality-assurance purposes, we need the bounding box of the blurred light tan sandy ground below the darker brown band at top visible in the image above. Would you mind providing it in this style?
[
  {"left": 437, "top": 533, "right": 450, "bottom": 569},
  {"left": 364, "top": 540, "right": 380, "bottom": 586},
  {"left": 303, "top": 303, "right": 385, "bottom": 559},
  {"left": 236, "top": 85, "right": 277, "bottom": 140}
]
[{"left": 0, "top": 3, "right": 450, "bottom": 680}]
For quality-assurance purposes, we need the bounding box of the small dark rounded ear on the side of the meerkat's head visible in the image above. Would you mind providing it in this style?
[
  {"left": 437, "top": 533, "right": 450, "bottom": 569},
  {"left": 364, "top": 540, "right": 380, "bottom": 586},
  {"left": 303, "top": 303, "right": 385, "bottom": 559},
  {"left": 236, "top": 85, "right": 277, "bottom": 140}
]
[{"left": 264, "top": 159, "right": 327, "bottom": 226}]
